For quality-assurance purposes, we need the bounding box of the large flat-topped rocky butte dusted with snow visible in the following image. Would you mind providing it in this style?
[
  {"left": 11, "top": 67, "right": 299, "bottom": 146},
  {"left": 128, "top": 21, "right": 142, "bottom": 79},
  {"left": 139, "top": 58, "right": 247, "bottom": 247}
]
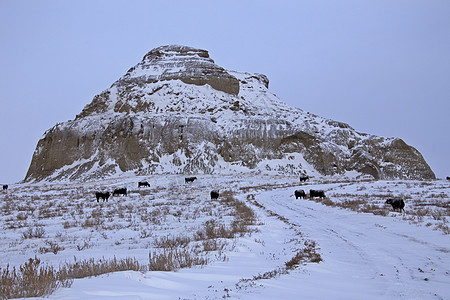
[{"left": 26, "top": 46, "right": 435, "bottom": 181}]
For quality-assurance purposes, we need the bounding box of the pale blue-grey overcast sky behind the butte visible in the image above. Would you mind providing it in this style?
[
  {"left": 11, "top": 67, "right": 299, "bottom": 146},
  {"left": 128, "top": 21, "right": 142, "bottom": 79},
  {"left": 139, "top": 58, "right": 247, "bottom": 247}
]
[{"left": 0, "top": 0, "right": 450, "bottom": 184}]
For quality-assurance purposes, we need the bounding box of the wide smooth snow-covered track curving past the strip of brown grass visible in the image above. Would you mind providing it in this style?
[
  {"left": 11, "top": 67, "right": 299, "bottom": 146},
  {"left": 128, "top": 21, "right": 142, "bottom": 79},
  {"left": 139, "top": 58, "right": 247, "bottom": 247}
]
[{"left": 253, "top": 189, "right": 450, "bottom": 299}]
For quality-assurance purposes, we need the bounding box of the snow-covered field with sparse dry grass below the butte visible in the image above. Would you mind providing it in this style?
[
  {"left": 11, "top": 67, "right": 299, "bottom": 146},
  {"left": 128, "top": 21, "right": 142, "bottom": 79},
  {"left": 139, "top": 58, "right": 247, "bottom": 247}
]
[{"left": 0, "top": 174, "right": 450, "bottom": 299}]
